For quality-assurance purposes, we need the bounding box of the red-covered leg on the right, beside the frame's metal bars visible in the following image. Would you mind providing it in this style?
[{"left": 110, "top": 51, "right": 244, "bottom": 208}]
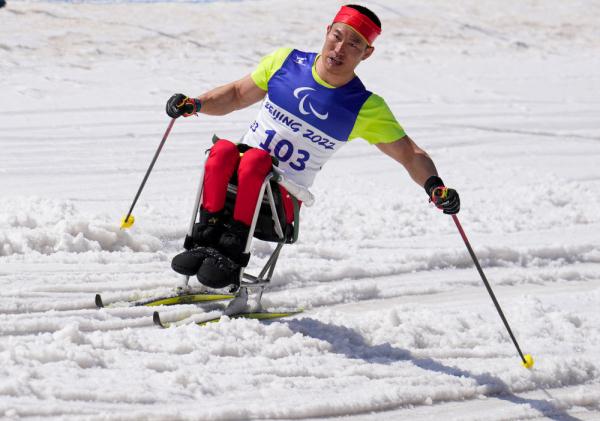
[{"left": 233, "top": 149, "right": 272, "bottom": 225}]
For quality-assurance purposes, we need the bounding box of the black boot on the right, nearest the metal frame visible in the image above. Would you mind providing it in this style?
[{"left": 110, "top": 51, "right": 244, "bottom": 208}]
[{"left": 197, "top": 221, "right": 250, "bottom": 288}]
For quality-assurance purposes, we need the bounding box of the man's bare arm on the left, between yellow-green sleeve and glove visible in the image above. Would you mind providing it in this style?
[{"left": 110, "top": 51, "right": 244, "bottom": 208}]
[{"left": 198, "top": 75, "right": 266, "bottom": 115}]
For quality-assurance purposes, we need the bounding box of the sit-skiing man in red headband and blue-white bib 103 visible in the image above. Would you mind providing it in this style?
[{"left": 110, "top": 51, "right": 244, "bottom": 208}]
[{"left": 166, "top": 5, "right": 460, "bottom": 288}]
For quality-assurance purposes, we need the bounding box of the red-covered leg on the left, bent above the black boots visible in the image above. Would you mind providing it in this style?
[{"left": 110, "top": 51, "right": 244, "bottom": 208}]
[{"left": 202, "top": 139, "right": 240, "bottom": 212}]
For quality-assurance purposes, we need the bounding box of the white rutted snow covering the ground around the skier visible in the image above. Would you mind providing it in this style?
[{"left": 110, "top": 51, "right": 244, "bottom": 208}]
[{"left": 0, "top": 0, "right": 600, "bottom": 420}]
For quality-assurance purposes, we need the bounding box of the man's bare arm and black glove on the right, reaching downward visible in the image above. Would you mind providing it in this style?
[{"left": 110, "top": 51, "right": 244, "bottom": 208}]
[{"left": 376, "top": 135, "right": 460, "bottom": 215}]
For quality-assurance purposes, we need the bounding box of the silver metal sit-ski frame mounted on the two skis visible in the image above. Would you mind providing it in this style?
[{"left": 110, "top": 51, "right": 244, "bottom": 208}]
[{"left": 183, "top": 151, "right": 299, "bottom": 314}]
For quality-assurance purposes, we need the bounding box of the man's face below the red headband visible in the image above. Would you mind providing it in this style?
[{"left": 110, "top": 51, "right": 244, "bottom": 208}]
[{"left": 321, "top": 23, "right": 374, "bottom": 75}]
